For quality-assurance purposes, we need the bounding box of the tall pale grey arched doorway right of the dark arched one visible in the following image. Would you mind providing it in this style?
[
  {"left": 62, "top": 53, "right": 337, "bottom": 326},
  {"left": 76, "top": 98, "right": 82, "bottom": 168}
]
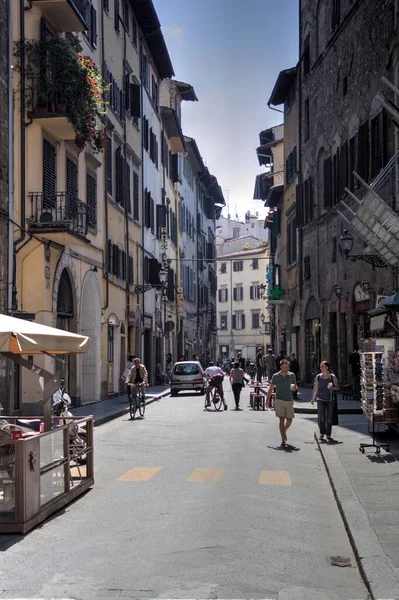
[{"left": 80, "top": 271, "right": 101, "bottom": 404}]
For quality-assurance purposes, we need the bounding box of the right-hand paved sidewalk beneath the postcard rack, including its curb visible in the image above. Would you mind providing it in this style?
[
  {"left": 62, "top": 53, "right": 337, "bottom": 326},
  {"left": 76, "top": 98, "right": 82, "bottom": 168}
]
[{"left": 310, "top": 415, "right": 399, "bottom": 600}]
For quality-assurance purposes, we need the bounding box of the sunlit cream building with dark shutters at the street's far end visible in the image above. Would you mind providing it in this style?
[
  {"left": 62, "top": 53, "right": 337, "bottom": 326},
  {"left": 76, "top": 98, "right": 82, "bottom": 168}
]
[{"left": 217, "top": 244, "right": 271, "bottom": 360}]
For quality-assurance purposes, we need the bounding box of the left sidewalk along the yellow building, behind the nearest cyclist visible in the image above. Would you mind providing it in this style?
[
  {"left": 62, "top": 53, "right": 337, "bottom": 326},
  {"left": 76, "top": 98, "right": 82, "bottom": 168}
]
[{"left": 72, "top": 385, "right": 170, "bottom": 427}]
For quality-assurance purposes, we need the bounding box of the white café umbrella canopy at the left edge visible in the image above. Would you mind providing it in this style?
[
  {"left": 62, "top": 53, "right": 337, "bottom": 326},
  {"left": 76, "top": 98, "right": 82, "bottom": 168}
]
[{"left": 0, "top": 315, "right": 90, "bottom": 354}]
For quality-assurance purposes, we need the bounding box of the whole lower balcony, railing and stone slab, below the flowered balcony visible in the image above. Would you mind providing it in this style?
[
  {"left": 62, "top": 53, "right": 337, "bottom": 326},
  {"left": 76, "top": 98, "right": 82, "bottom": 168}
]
[{"left": 27, "top": 192, "right": 89, "bottom": 245}]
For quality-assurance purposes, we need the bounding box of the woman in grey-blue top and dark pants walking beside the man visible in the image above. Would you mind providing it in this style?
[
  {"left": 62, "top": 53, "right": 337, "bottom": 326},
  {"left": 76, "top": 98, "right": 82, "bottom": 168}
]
[{"left": 311, "top": 360, "right": 339, "bottom": 442}]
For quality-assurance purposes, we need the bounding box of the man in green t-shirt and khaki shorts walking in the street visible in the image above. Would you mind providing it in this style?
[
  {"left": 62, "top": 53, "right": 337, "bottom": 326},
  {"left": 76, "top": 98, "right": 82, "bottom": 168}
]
[{"left": 266, "top": 358, "right": 297, "bottom": 448}]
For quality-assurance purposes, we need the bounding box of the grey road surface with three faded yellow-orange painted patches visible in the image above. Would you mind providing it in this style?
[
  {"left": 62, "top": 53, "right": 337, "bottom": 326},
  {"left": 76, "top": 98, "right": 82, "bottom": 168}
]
[{"left": 0, "top": 386, "right": 368, "bottom": 600}]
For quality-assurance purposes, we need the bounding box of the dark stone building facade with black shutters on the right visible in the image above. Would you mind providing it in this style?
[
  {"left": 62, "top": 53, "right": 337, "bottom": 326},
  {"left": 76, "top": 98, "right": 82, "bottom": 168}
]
[{"left": 297, "top": 0, "right": 397, "bottom": 383}]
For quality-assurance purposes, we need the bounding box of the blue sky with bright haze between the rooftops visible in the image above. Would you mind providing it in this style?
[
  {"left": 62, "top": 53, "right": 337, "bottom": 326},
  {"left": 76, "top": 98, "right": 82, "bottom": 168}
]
[{"left": 153, "top": 0, "right": 298, "bottom": 218}]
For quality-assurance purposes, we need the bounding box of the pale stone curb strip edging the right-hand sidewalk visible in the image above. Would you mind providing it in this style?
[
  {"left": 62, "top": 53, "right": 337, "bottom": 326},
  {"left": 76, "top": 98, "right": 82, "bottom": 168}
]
[{"left": 314, "top": 433, "right": 399, "bottom": 600}]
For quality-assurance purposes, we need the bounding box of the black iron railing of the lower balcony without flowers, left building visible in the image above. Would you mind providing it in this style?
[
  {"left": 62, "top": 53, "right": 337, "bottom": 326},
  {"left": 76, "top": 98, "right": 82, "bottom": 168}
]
[{"left": 28, "top": 192, "right": 89, "bottom": 236}]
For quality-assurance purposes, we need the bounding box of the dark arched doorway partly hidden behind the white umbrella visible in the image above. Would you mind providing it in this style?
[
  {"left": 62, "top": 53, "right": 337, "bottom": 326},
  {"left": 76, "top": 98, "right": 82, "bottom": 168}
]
[{"left": 56, "top": 269, "right": 78, "bottom": 404}]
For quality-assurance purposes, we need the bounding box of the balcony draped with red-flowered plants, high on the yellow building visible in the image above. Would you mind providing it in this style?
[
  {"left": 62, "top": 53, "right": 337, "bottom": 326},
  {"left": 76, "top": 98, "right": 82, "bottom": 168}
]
[{"left": 26, "top": 77, "right": 76, "bottom": 140}]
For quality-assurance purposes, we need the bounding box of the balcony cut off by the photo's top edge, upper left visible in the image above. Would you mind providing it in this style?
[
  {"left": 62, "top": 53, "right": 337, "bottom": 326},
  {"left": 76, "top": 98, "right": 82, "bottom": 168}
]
[{"left": 34, "top": 0, "right": 88, "bottom": 32}]
